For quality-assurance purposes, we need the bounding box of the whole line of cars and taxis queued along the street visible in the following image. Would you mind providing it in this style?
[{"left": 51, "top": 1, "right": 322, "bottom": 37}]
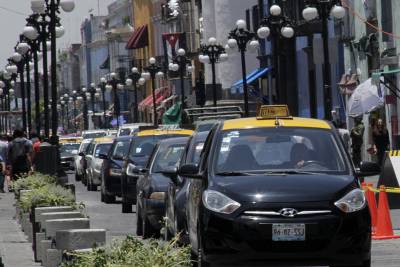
[{"left": 57, "top": 106, "right": 380, "bottom": 267}]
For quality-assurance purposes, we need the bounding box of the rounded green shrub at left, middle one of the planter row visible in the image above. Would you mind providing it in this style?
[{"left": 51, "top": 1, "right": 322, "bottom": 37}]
[{"left": 19, "top": 184, "right": 76, "bottom": 212}]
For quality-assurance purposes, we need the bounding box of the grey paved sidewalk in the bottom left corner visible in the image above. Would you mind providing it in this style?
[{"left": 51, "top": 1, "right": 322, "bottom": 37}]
[{"left": 0, "top": 193, "right": 40, "bottom": 267}]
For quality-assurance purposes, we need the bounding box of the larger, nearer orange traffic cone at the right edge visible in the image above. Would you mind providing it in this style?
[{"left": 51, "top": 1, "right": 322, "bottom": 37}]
[{"left": 372, "top": 186, "right": 400, "bottom": 240}]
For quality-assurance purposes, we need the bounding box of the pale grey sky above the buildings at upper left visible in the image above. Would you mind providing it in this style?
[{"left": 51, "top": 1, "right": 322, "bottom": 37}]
[{"left": 0, "top": 0, "right": 114, "bottom": 67}]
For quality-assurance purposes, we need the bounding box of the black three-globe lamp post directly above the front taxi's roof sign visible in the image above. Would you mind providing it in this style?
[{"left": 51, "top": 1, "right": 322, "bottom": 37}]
[{"left": 257, "top": 5, "right": 294, "bottom": 104}]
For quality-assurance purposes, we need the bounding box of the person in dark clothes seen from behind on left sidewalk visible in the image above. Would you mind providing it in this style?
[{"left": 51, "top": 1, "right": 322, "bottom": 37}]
[{"left": 8, "top": 129, "right": 33, "bottom": 181}]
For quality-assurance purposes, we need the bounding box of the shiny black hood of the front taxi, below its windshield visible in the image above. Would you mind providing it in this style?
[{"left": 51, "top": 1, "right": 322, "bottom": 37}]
[{"left": 209, "top": 174, "right": 357, "bottom": 202}]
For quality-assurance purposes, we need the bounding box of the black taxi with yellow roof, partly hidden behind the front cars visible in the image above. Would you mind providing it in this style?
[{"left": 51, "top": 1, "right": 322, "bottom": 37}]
[{"left": 121, "top": 126, "right": 193, "bottom": 213}]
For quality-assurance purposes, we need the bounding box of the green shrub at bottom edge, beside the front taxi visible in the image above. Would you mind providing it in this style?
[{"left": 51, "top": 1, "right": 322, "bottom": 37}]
[{"left": 62, "top": 236, "right": 192, "bottom": 267}]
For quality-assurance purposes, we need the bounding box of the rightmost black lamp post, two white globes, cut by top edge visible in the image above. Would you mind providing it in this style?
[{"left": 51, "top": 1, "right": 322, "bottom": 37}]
[{"left": 302, "top": 0, "right": 346, "bottom": 120}]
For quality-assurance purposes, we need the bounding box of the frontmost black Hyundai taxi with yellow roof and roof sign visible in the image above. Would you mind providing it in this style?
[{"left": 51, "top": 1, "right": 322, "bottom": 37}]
[{"left": 178, "top": 106, "right": 380, "bottom": 266}]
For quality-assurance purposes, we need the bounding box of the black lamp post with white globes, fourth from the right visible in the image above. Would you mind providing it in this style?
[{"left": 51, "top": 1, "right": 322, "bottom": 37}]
[{"left": 199, "top": 37, "right": 228, "bottom": 107}]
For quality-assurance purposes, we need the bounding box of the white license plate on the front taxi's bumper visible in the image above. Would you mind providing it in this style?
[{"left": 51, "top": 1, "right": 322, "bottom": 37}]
[{"left": 272, "top": 223, "right": 306, "bottom": 241}]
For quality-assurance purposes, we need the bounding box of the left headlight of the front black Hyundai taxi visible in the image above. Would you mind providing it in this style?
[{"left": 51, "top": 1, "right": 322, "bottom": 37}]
[{"left": 203, "top": 190, "right": 240, "bottom": 214}]
